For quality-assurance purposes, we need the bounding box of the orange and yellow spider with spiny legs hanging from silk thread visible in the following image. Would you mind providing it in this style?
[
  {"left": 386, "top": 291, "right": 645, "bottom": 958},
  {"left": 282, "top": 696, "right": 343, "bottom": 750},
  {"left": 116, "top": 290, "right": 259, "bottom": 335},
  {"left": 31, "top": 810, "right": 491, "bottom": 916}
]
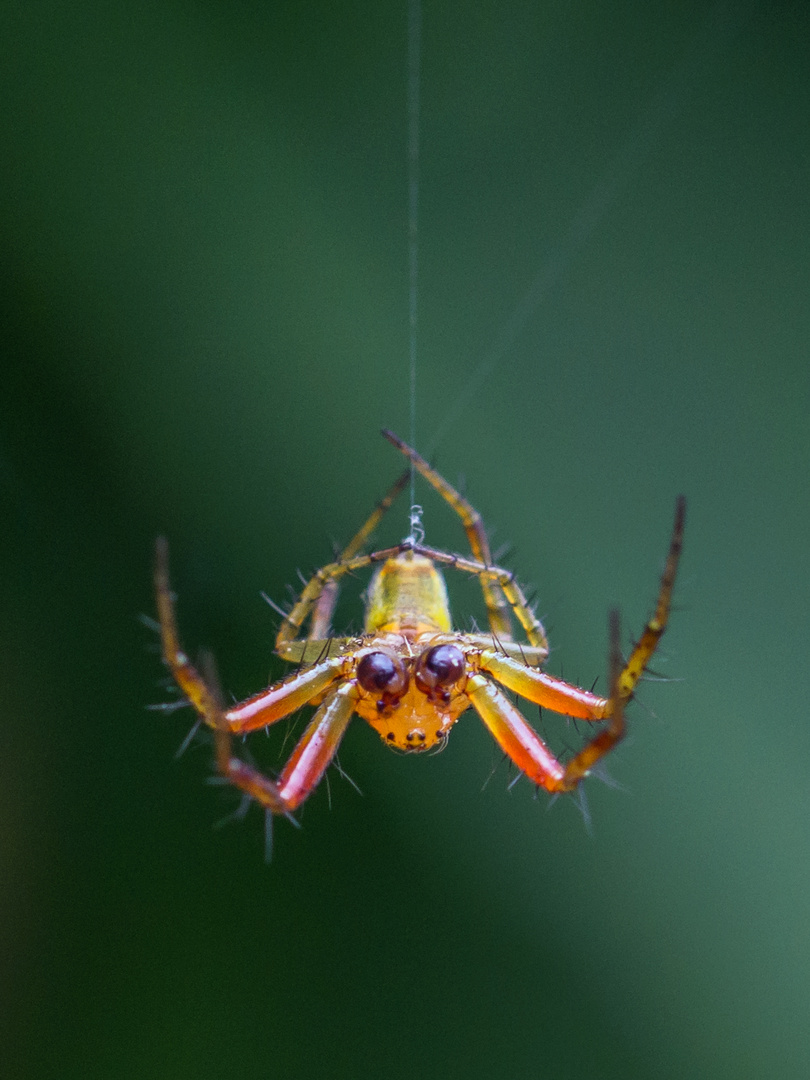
[{"left": 154, "top": 431, "right": 686, "bottom": 819}]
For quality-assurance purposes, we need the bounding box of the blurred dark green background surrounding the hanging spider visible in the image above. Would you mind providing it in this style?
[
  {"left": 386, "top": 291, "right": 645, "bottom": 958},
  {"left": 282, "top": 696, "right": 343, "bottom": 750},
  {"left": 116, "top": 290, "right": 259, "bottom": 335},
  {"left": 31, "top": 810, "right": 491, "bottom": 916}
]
[{"left": 0, "top": 0, "right": 810, "bottom": 1080}]
